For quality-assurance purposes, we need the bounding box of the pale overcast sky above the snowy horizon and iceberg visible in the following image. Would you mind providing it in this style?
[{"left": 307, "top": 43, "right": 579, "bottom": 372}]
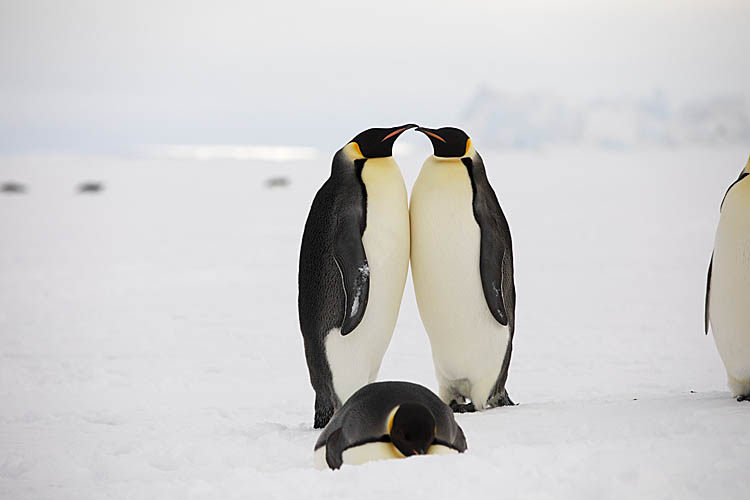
[{"left": 0, "top": 0, "right": 750, "bottom": 152}]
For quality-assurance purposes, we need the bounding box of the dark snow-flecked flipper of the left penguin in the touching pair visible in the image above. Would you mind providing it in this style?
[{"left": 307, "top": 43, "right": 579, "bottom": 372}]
[{"left": 334, "top": 212, "right": 370, "bottom": 335}]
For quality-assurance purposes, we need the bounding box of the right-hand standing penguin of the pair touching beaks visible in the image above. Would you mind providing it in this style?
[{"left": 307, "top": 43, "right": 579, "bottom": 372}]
[{"left": 409, "top": 127, "right": 516, "bottom": 412}]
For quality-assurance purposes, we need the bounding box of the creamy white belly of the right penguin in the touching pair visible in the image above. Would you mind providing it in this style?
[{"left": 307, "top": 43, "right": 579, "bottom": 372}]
[{"left": 410, "top": 157, "right": 510, "bottom": 409}]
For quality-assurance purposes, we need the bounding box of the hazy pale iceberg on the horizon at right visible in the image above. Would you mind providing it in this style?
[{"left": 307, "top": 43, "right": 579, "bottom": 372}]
[{"left": 461, "top": 87, "right": 750, "bottom": 149}]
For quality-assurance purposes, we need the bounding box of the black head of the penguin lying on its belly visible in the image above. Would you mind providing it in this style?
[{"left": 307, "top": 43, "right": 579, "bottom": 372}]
[{"left": 390, "top": 403, "right": 435, "bottom": 457}]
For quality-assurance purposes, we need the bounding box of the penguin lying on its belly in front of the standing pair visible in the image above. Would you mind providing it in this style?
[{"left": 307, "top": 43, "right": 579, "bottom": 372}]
[{"left": 315, "top": 382, "right": 466, "bottom": 469}]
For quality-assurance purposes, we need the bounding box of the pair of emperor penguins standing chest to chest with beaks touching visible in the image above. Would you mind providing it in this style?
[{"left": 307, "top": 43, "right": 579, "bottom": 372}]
[{"left": 298, "top": 124, "right": 515, "bottom": 428}]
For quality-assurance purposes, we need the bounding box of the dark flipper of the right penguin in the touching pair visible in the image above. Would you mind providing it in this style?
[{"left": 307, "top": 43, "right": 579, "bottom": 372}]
[{"left": 462, "top": 153, "right": 516, "bottom": 328}]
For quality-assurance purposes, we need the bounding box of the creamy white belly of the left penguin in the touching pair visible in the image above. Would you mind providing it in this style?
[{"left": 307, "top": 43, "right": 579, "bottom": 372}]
[{"left": 326, "top": 158, "right": 409, "bottom": 404}]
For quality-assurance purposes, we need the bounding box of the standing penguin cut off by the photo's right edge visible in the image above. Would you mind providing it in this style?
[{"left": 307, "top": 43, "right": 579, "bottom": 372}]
[{"left": 704, "top": 158, "right": 750, "bottom": 401}]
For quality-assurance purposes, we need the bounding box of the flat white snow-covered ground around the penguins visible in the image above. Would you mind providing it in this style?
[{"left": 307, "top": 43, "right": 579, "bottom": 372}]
[{"left": 0, "top": 144, "right": 750, "bottom": 499}]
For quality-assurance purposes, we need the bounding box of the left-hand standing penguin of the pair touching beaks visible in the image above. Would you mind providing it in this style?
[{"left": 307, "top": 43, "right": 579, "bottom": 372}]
[{"left": 298, "top": 125, "right": 416, "bottom": 429}]
